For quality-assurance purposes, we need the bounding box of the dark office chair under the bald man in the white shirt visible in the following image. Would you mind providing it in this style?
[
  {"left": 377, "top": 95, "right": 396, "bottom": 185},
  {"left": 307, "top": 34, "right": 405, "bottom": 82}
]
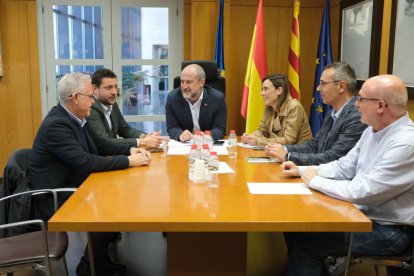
[{"left": 344, "top": 219, "right": 414, "bottom": 276}]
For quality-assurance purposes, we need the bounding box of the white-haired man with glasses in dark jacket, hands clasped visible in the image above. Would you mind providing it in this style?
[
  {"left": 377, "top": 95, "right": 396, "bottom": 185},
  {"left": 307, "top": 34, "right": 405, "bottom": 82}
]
[{"left": 28, "top": 73, "right": 151, "bottom": 275}]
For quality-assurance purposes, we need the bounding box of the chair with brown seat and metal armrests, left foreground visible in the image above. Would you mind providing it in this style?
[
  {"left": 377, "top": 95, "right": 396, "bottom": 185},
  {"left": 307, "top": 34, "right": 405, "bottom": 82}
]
[{"left": 0, "top": 189, "right": 76, "bottom": 276}]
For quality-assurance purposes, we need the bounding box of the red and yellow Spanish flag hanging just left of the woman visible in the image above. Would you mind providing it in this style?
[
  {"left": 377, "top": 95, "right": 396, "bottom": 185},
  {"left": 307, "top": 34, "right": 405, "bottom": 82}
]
[{"left": 241, "top": 0, "right": 267, "bottom": 133}]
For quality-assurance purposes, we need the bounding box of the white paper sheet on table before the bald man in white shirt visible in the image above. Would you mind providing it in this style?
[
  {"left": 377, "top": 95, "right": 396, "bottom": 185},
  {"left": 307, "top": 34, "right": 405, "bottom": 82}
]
[{"left": 247, "top": 182, "right": 312, "bottom": 195}]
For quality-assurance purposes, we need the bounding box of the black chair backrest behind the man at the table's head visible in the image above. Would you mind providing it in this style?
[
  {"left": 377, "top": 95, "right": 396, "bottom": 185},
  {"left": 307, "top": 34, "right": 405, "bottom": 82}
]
[{"left": 174, "top": 60, "right": 226, "bottom": 94}]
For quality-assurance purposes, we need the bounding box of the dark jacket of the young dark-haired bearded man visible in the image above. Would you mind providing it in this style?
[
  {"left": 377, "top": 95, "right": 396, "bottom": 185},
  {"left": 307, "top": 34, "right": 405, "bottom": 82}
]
[{"left": 86, "top": 99, "right": 145, "bottom": 146}]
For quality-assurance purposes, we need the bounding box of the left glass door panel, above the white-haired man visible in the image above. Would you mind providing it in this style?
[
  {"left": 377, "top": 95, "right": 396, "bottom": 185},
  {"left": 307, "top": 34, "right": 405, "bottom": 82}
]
[{"left": 39, "top": 0, "right": 112, "bottom": 112}]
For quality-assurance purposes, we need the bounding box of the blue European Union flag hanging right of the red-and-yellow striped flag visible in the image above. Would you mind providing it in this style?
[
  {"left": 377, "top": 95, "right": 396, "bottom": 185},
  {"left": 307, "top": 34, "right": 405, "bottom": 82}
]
[{"left": 310, "top": 0, "right": 332, "bottom": 137}]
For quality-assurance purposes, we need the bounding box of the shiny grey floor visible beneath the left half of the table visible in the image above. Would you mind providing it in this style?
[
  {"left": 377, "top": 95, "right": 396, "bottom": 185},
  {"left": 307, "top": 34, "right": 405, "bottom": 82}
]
[{"left": 14, "top": 232, "right": 167, "bottom": 276}]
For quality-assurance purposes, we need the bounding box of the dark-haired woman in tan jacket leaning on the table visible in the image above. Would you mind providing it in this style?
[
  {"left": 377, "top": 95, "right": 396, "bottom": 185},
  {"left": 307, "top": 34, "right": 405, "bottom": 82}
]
[{"left": 242, "top": 74, "right": 312, "bottom": 146}]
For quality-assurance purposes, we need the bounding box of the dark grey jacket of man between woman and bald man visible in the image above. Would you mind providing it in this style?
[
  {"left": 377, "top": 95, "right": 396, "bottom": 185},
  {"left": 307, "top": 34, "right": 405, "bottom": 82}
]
[{"left": 286, "top": 97, "right": 367, "bottom": 165}]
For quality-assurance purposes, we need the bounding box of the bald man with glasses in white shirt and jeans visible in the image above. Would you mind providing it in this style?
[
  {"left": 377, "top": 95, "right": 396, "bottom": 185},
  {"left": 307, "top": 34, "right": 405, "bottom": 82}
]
[{"left": 282, "top": 75, "right": 414, "bottom": 275}]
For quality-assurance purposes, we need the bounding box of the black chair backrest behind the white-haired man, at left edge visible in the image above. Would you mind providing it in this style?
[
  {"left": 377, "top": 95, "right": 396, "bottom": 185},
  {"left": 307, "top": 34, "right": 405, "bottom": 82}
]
[{"left": 0, "top": 149, "right": 32, "bottom": 237}]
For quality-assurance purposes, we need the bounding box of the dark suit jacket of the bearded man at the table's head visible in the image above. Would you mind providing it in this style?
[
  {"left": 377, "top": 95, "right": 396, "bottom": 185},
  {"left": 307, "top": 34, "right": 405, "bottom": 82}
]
[{"left": 165, "top": 86, "right": 227, "bottom": 140}]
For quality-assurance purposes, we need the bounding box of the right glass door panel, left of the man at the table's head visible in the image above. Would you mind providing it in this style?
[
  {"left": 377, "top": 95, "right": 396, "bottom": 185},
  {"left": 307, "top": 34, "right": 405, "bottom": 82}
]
[{"left": 112, "top": 0, "right": 183, "bottom": 135}]
